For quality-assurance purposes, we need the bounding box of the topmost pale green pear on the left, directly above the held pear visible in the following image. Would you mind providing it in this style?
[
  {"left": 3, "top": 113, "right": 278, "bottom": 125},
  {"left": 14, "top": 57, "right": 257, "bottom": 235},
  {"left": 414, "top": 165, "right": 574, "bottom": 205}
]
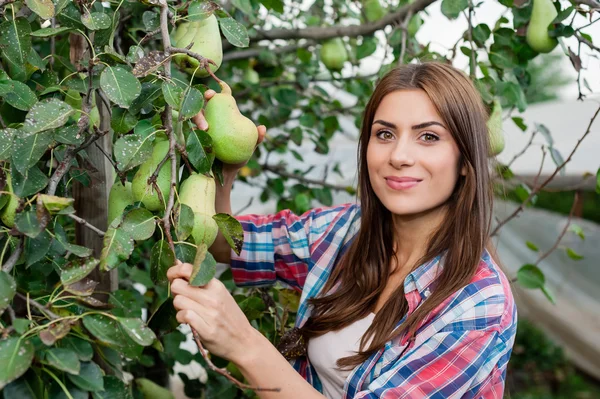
[{"left": 173, "top": 14, "right": 223, "bottom": 78}]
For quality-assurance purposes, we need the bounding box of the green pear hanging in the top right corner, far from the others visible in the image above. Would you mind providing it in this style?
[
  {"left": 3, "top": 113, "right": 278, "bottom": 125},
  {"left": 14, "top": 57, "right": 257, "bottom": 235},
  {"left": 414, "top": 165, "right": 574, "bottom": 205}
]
[{"left": 526, "top": 0, "right": 558, "bottom": 53}]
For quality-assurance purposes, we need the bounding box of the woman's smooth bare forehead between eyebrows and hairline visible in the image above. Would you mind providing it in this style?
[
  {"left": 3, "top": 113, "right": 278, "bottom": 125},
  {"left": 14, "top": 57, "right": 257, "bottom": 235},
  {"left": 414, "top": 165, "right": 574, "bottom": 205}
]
[{"left": 374, "top": 89, "right": 442, "bottom": 126}]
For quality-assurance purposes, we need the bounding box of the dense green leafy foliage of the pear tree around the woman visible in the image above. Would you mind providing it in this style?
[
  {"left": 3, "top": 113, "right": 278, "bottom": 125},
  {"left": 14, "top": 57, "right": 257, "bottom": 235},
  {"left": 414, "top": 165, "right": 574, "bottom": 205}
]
[{"left": 0, "top": 0, "right": 600, "bottom": 398}]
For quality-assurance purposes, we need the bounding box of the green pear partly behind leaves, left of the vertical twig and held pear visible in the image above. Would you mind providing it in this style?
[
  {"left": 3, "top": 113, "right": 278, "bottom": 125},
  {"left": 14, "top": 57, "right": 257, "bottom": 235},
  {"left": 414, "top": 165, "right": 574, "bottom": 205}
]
[{"left": 131, "top": 135, "right": 171, "bottom": 211}]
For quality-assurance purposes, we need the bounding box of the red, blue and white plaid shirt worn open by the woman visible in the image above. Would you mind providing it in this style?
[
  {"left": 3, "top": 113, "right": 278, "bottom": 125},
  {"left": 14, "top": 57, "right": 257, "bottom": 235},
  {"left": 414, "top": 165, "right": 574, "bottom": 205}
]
[{"left": 231, "top": 204, "right": 517, "bottom": 399}]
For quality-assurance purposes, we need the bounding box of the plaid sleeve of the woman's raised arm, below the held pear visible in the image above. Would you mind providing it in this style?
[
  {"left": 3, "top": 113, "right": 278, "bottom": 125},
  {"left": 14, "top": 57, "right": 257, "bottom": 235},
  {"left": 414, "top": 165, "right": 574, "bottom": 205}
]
[{"left": 231, "top": 204, "right": 357, "bottom": 291}]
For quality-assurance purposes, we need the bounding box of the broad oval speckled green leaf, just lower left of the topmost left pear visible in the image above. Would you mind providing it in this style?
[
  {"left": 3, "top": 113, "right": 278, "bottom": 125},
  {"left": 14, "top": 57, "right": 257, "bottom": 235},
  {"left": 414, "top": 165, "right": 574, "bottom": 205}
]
[{"left": 100, "top": 66, "right": 142, "bottom": 108}]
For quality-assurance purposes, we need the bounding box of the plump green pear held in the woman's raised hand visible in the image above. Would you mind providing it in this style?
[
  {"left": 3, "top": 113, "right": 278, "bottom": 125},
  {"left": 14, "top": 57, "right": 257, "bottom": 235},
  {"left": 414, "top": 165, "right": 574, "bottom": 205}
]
[{"left": 204, "top": 81, "right": 258, "bottom": 164}]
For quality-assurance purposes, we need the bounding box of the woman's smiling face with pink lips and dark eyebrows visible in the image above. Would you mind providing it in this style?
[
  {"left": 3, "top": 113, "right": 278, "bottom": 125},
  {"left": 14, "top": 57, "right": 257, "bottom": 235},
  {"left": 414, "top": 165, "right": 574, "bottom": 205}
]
[{"left": 367, "top": 89, "right": 460, "bottom": 216}]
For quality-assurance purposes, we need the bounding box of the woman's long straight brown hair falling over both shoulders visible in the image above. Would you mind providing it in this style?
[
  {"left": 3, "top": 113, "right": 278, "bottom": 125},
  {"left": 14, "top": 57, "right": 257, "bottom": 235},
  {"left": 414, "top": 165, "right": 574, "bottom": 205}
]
[{"left": 302, "top": 62, "right": 492, "bottom": 369}]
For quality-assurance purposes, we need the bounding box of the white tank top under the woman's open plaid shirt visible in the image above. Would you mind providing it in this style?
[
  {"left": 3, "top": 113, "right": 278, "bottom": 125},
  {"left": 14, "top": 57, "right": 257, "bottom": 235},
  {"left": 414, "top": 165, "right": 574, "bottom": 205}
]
[{"left": 307, "top": 313, "right": 375, "bottom": 399}]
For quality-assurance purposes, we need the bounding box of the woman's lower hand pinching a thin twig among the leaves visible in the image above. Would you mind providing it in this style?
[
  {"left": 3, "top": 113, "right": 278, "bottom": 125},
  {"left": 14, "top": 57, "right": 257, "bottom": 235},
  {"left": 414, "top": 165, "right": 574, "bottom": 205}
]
[{"left": 167, "top": 261, "right": 261, "bottom": 364}]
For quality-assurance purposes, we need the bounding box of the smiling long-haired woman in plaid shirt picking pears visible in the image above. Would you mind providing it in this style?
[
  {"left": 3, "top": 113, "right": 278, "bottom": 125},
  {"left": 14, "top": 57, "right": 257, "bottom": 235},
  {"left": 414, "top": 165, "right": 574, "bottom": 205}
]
[{"left": 168, "top": 62, "right": 517, "bottom": 399}]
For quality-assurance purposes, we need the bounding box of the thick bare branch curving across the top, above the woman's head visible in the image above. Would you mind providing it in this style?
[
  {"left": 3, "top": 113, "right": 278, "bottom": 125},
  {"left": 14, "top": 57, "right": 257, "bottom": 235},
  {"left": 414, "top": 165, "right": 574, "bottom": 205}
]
[{"left": 250, "top": 0, "right": 436, "bottom": 41}]
